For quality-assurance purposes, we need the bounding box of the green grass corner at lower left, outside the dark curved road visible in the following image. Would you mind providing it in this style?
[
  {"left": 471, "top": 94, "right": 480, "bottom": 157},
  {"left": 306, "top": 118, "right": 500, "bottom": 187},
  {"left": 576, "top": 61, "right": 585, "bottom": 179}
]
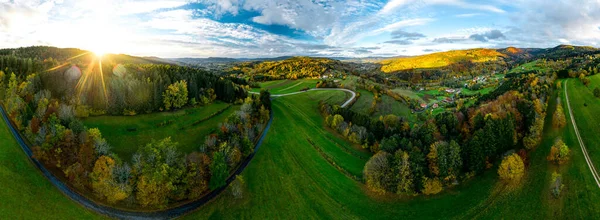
[{"left": 0, "top": 113, "right": 99, "bottom": 219}]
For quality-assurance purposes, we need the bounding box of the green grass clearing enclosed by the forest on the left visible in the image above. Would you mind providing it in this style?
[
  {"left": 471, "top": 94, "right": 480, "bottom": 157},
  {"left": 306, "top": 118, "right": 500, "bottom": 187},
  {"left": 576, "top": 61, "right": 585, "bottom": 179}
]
[{"left": 83, "top": 102, "right": 239, "bottom": 160}]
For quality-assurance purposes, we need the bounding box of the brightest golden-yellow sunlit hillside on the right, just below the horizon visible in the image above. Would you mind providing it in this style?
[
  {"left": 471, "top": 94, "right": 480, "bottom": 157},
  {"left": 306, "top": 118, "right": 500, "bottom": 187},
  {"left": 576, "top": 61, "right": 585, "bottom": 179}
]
[{"left": 381, "top": 49, "right": 505, "bottom": 73}]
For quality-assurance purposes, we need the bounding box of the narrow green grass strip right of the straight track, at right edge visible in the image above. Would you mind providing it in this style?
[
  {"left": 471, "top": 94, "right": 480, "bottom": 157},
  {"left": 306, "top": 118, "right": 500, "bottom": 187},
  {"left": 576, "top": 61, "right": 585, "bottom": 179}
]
[{"left": 565, "top": 75, "right": 600, "bottom": 173}]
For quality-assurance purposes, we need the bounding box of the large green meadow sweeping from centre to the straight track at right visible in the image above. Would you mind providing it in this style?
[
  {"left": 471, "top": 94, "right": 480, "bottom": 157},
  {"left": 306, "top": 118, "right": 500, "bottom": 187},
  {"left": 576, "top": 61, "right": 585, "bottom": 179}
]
[{"left": 186, "top": 87, "right": 600, "bottom": 219}]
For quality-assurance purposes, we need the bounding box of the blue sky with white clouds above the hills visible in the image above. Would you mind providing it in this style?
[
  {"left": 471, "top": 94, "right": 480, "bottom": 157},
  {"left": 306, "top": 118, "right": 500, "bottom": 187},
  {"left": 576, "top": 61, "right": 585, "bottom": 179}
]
[{"left": 0, "top": 0, "right": 600, "bottom": 58}]
